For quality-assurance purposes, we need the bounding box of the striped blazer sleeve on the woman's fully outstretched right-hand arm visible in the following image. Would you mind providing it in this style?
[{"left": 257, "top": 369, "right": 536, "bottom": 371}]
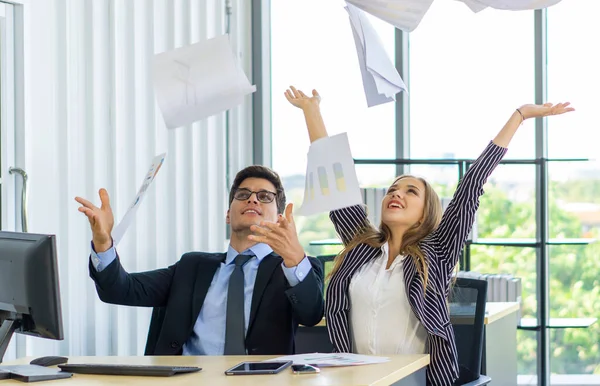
[{"left": 430, "top": 142, "right": 507, "bottom": 271}]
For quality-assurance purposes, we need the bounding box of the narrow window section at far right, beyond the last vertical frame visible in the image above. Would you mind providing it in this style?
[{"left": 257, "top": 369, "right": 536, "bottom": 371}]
[{"left": 547, "top": 0, "right": 600, "bottom": 375}]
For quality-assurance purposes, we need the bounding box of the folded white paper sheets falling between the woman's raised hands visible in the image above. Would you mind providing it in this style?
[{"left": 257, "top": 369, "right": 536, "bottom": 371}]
[{"left": 346, "top": 4, "right": 406, "bottom": 107}]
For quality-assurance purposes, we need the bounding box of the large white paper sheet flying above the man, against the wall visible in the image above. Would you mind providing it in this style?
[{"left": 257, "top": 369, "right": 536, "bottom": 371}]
[{"left": 154, "top": 35, "right": 256, "bottom": 129}]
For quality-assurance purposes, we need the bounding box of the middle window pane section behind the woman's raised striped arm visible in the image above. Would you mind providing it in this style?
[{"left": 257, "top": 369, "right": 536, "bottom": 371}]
[{"left": 409, "top": 1, "right": 537, "bottom": 375}]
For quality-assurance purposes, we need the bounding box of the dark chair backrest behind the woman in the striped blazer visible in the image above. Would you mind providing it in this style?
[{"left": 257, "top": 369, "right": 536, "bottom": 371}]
[{"left": 449, "top": 277, "right": 487, "bottom": 385}]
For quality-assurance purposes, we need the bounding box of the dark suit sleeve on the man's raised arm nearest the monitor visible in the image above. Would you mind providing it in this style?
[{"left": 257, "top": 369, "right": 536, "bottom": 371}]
[{"left": 89, "top": 255, "right": 177, "bottom": 307}]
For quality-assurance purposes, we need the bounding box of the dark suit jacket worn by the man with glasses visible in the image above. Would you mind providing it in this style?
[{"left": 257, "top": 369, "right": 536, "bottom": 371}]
[{"left": 90, "top": 252, "right": 324, "bottom": 355}]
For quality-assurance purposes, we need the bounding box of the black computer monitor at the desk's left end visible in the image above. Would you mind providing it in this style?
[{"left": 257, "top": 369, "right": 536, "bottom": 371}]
[{"left": 0, "top": 231, "right": 64, "bottom": 363}]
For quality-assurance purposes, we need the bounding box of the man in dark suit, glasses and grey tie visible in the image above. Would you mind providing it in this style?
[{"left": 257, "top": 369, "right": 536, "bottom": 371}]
[{"left": 75, "top": 166, "right": 324, "bottom": 355}]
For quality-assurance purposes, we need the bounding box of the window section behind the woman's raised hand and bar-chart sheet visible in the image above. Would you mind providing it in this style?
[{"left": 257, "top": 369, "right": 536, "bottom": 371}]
[{"left": 271, "top": 0, "right": 396, "bottom": 254}]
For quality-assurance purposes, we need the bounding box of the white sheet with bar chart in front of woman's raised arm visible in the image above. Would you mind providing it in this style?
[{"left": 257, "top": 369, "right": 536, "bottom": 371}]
[{"left": 299, "top": 133, "right": 362, "bottom": 216}]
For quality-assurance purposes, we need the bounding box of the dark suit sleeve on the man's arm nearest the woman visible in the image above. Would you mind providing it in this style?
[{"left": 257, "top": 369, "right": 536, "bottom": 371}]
[{"left": 286, "top": 257, "right": 325, "bottom": 327}]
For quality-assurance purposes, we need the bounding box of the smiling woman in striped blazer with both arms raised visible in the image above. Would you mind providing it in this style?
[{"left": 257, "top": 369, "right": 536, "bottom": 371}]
[{"left": 285, "top": 87, "right": 573, "bottom": 385}]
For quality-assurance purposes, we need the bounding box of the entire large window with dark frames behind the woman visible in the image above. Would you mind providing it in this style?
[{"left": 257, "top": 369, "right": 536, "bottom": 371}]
[{"left": 271, "top": 0, "right": 600, "bottom": 384}]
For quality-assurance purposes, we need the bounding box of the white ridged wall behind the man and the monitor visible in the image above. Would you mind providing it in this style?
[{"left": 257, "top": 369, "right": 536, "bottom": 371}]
[{"left": 7, "top": 0, "right": 251, "bottom": 358}]
